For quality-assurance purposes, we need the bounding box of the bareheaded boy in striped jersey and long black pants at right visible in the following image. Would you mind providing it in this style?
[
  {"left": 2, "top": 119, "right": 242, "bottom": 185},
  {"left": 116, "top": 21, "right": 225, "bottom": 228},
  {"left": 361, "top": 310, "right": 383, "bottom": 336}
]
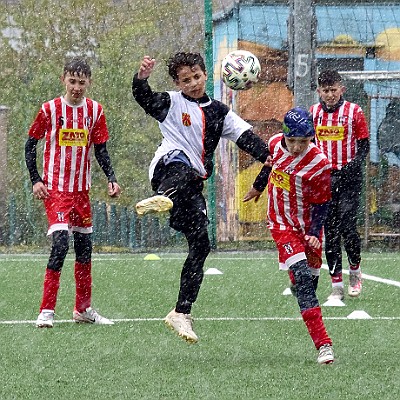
[{"left": 310, "top": 70, "right": 369, "bottom": 300}]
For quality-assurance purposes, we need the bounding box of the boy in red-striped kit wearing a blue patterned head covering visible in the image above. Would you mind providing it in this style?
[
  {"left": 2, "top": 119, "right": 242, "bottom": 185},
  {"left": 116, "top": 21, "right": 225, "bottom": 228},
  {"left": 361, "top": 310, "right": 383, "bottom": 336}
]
[{"left": 243, "top": 107, "right": 334, "bottom": 364}]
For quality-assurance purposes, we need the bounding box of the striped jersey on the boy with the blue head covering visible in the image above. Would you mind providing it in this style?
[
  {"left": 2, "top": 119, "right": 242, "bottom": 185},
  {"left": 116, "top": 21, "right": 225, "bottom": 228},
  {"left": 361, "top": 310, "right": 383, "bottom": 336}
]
[{"left": 268, "top": 133, "right": 331, "bottom": 233}]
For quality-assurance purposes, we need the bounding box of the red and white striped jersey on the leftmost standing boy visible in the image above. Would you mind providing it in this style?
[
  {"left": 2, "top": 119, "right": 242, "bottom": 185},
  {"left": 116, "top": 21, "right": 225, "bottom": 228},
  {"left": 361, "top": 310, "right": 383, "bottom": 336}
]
[{"left": 29, "top": 97, "right": 109, "bottom": 192}]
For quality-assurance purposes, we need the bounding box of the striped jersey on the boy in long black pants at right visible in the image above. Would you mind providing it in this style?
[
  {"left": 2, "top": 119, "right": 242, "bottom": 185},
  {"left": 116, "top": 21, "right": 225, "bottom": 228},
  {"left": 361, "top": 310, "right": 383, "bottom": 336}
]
[{"left": 310, "top": 100, "right": 369, "bottom": 170}]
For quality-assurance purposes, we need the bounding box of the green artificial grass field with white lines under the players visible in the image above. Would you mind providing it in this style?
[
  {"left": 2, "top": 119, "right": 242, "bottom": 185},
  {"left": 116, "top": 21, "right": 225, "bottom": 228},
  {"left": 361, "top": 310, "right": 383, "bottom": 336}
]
[{"left": 0, "top": 251, "right": 400, "bottom": 400}]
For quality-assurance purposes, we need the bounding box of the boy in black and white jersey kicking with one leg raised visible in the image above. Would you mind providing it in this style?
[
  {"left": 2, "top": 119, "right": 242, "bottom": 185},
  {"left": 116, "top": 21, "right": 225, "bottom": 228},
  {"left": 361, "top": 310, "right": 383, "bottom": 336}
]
[{"left": 132, "top": 52, "right": 269, "bottom": 343}]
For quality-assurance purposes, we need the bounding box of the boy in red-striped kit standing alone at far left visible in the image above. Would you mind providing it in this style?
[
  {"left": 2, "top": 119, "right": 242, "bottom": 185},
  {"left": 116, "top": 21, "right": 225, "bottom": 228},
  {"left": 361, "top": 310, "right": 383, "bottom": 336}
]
[{"left": 25, "top": 58, "right": 120, "bottom": 328}]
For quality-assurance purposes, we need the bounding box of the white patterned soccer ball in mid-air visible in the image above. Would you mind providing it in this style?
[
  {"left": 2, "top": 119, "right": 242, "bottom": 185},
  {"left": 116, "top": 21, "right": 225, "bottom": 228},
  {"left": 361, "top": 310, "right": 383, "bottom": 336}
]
[{"left": 221, "top": 50, "right": 261, "bottom": 90}]
